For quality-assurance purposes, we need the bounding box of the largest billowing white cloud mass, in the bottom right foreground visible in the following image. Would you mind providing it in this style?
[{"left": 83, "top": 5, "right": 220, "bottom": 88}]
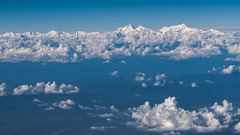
[{"left": 127, "top": 97, "right": 238, "bottom": 133}]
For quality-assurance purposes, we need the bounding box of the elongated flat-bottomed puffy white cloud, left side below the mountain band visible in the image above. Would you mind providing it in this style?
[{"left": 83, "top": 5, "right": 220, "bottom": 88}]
[{"left": 13, "top": 82, "right": 79, "bottom": 95}]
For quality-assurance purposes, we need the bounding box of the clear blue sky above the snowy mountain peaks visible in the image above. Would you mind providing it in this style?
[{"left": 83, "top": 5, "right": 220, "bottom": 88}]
[{"left": 0, "top": 0, "right": 240, "bottom": 34}]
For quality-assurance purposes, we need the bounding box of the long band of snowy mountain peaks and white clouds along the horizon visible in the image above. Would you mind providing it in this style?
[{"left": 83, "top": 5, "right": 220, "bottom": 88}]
[{"left": 0, "top": 24, "right": 240, "bottom": 62}]
